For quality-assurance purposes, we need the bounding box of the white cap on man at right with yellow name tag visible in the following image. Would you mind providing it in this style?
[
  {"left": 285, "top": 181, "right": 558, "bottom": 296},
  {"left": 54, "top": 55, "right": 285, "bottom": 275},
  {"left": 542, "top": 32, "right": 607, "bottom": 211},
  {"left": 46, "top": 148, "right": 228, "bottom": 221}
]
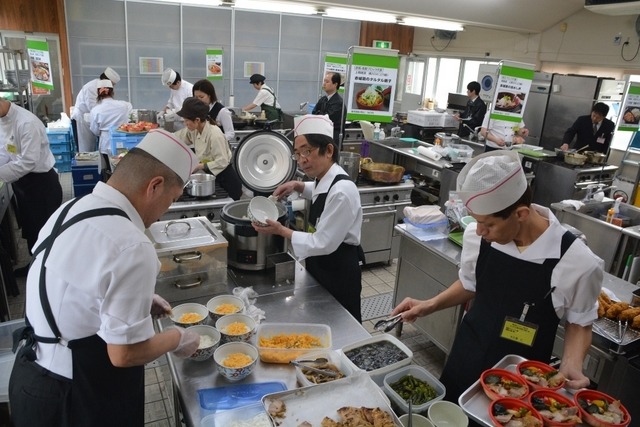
[{"left": 457, "top": 150, "right": 527, "bottom": 215}]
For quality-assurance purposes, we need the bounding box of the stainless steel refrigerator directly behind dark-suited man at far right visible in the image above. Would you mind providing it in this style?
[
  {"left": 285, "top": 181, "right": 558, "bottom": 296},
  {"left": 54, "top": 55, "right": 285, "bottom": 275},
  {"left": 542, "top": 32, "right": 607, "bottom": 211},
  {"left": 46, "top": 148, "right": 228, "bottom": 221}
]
[{"left": 540, "top": 74, "right": 600, "bottom": 150}]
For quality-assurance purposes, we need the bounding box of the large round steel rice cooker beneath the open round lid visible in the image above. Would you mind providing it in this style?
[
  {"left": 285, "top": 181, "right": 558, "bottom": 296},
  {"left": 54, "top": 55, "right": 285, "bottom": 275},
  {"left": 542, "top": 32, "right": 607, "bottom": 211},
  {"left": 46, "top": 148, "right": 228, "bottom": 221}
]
[{"left": 220, "top": 200, "right": 287, "bottom": 270}]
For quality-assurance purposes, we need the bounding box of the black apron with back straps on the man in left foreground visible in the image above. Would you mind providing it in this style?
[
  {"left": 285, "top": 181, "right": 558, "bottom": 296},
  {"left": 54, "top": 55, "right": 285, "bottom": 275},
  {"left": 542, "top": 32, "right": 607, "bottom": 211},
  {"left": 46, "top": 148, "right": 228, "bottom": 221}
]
[{"left": 14, "top": 199, "right": 144, "bottom": 427}]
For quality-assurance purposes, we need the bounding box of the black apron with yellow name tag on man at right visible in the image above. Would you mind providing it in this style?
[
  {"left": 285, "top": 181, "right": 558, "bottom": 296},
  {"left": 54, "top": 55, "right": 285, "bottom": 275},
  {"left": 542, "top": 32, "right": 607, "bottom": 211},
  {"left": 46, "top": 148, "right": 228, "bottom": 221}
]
[{"left": 440, "top": 231, "right": 575, "bottom": 403}]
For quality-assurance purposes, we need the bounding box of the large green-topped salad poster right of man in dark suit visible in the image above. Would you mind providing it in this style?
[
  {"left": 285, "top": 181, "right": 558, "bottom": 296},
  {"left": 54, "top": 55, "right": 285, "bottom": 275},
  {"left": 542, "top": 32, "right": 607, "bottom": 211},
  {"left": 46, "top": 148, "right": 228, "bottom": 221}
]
[{"left": 345, "top": 48, "right": 400, "bottom": 123}]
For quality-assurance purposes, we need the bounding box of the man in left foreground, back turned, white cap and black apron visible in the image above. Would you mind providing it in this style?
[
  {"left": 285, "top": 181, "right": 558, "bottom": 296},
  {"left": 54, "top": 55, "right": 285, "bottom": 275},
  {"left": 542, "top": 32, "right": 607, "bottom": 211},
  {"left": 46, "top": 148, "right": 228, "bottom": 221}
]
[{"left": 9, "top": 130, "right": 200, "bottom": 427}]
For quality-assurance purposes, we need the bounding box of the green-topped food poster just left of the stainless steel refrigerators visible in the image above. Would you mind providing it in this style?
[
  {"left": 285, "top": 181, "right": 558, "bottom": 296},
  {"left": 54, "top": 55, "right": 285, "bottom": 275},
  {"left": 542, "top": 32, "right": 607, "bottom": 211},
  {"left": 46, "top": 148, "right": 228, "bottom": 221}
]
[{"left": 489, "top": 64, "right": 534, "bottom": 123}]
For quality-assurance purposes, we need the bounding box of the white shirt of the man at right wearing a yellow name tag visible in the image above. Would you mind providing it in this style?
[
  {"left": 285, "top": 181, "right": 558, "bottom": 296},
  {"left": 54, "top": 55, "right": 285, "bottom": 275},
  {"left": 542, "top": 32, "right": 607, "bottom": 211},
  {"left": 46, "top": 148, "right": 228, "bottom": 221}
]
[{"left": 458, "top": 204, "right": 604, "bottom": 326}]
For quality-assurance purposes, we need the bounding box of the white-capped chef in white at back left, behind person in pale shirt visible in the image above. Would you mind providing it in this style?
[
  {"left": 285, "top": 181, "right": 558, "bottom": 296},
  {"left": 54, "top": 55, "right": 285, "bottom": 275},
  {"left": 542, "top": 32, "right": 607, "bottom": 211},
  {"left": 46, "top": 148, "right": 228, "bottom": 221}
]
[{"left": 71, "top": 67, "right": 120, "bottom": 152}]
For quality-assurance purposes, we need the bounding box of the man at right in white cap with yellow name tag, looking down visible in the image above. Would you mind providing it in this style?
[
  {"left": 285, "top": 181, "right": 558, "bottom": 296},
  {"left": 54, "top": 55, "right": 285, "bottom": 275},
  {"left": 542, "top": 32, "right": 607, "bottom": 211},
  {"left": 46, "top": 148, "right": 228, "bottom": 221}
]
[{"left": 393, "top": 151, "right": 604, "bottom": 402}]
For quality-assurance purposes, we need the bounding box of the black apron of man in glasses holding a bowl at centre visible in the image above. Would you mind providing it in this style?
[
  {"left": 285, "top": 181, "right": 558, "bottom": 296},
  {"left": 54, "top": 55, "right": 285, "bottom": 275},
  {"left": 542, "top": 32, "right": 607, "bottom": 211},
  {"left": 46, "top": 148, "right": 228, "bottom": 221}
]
[{"left": 305, "top": 175, "right": 364, "bottom": 322}]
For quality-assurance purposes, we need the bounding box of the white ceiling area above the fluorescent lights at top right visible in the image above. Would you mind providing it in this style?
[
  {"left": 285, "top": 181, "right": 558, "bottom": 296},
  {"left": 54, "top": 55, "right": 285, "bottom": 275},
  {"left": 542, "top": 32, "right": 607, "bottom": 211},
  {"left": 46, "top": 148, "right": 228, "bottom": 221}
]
[{"left": 298, "top": 0, "right": 584, "bottom": 33}]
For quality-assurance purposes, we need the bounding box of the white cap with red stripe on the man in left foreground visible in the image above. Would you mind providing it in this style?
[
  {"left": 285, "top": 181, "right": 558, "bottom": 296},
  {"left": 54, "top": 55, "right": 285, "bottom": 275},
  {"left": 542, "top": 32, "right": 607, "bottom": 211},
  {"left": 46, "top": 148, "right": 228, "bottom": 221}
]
[{"left": 136, "top": 129, "right": 198, "bottom": 182}]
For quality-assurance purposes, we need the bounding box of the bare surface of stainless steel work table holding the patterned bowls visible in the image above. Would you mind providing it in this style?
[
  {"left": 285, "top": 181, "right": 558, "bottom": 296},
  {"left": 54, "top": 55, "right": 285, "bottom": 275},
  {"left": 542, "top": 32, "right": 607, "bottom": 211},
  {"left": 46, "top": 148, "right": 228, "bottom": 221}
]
[{"left": 158, "top": 263, "right": 371, "bottom": 426}]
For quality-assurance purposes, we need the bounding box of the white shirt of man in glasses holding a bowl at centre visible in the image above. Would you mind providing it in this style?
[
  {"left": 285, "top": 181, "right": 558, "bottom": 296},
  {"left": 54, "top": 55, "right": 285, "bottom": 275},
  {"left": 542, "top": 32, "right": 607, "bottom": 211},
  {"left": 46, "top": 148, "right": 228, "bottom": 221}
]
[{"left": 291, "top": 163, "right": 362, "bottom": 259}]
